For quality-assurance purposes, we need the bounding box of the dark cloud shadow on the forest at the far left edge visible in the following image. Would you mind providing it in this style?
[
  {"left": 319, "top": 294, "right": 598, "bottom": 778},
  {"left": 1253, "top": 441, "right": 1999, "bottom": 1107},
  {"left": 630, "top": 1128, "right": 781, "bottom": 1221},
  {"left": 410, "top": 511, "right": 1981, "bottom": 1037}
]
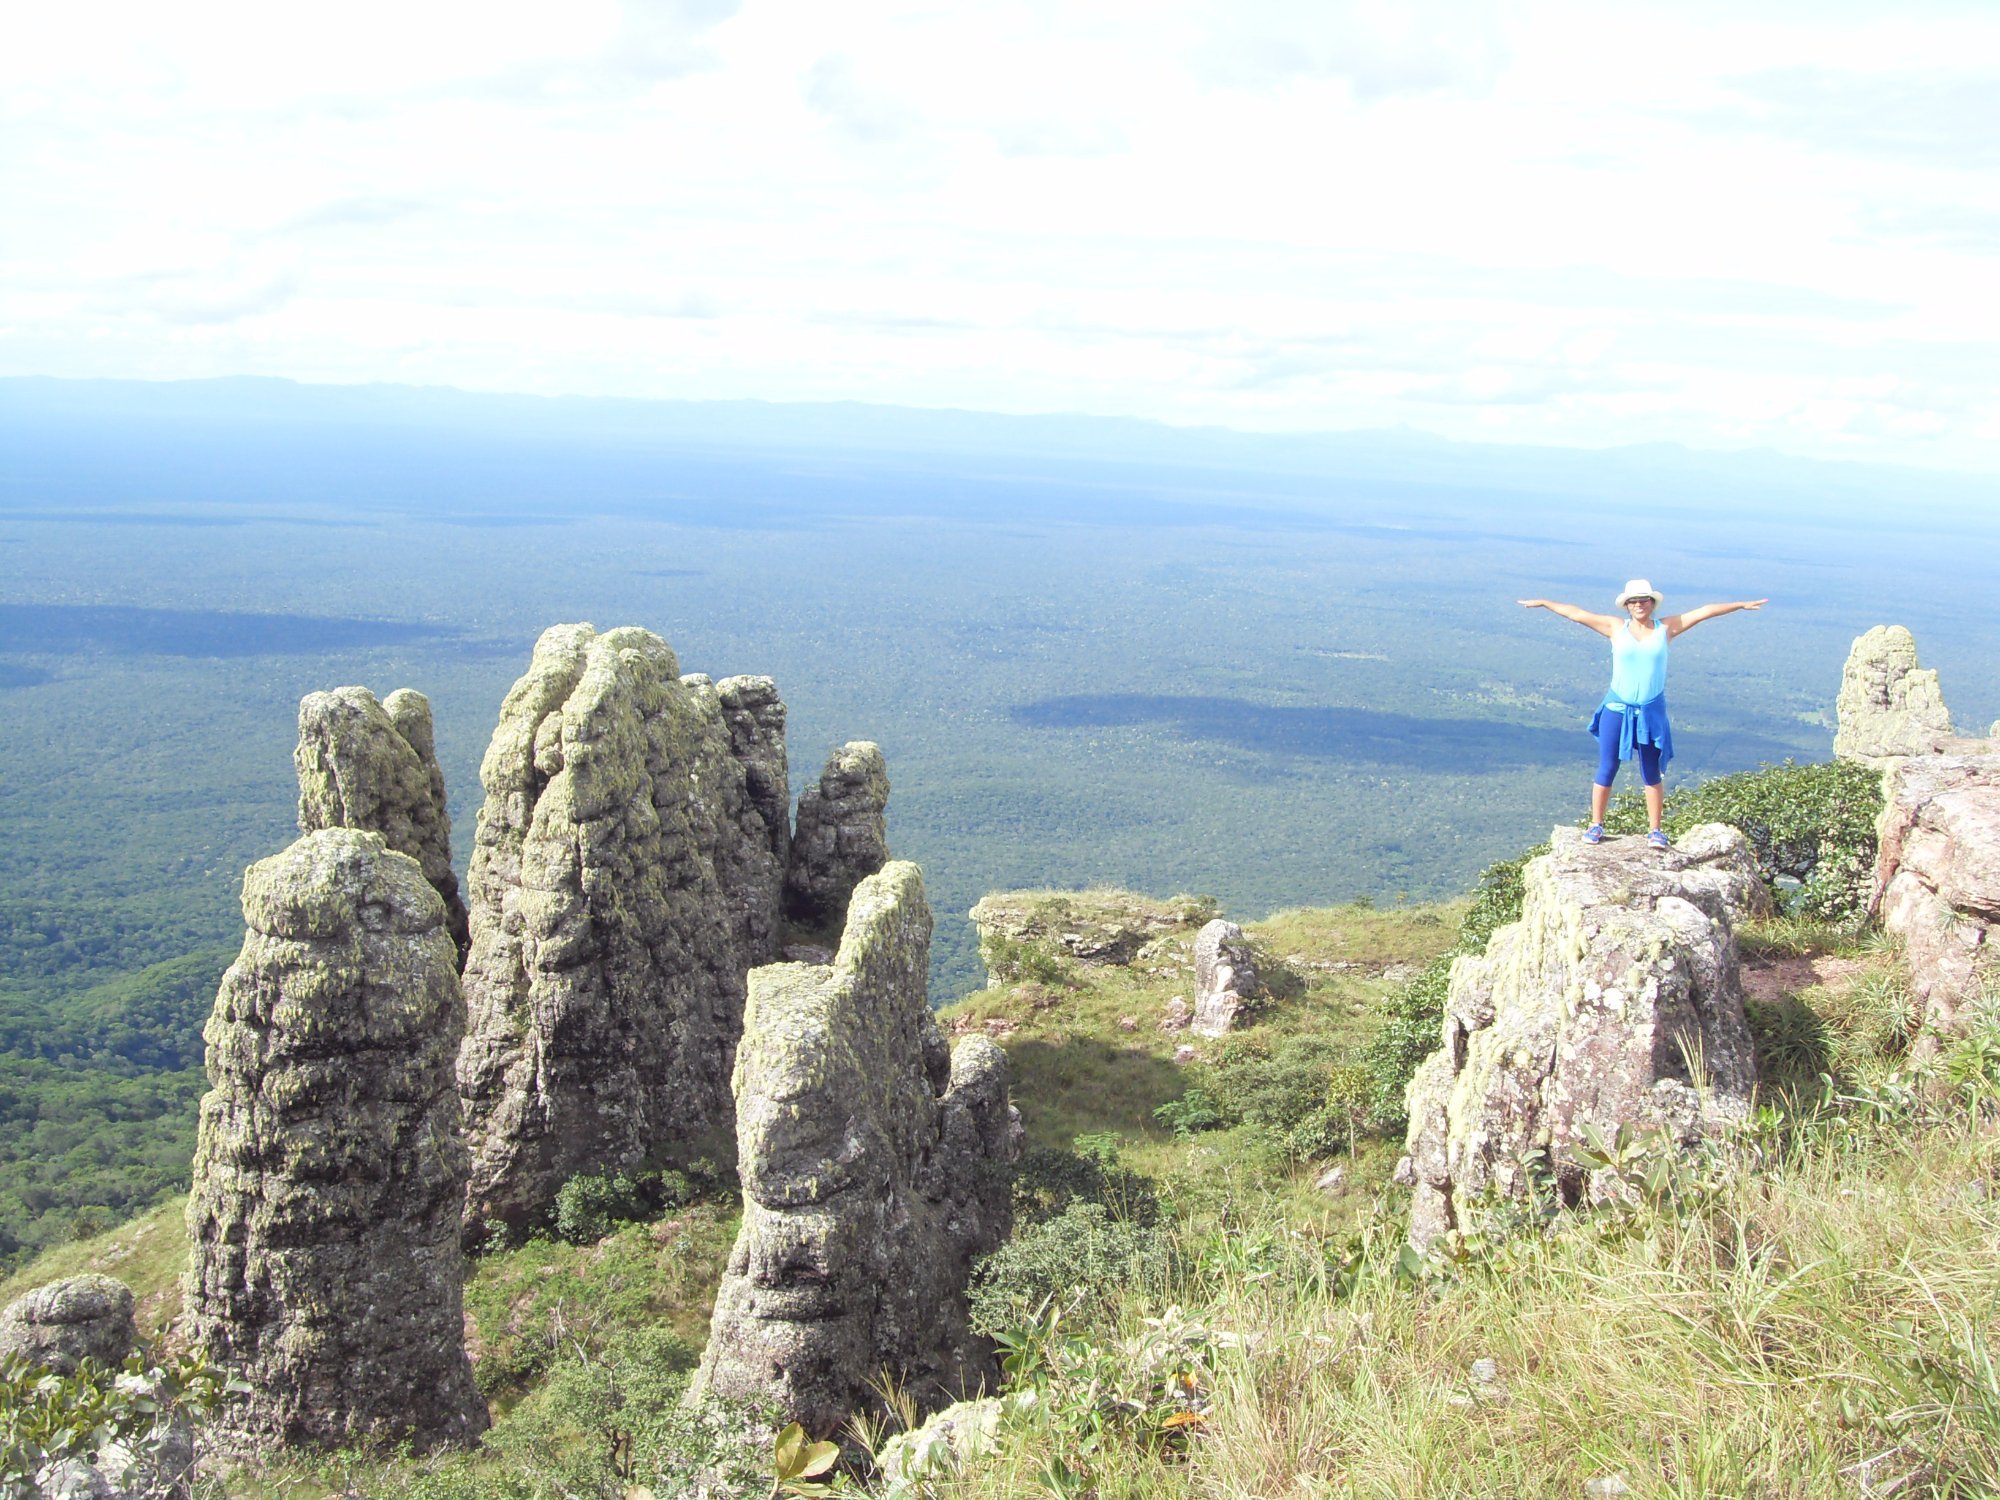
[{"left": 0, "top": 604, "right": 464, "bottom": 656}]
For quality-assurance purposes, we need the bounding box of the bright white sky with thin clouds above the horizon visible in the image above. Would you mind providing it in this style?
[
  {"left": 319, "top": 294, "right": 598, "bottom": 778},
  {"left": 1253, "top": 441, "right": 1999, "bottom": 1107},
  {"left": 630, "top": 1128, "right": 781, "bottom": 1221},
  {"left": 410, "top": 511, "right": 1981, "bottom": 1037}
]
[{"left": 11, "top": 0, "right": 2000, "bottom": 474}]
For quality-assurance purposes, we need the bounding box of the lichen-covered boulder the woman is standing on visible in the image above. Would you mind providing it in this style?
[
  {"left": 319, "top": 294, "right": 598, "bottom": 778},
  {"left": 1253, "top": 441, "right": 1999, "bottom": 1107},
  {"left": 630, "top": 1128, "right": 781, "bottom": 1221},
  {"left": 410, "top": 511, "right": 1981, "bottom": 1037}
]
[{"left": 1398, "top": 824, "right": 1770, "bottom": 1246}]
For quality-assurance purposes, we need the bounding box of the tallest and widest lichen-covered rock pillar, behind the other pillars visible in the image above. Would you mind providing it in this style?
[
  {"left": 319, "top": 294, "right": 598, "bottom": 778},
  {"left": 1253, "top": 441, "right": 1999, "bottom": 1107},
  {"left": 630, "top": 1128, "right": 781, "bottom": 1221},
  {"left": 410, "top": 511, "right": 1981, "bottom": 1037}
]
[{"left": 458, "top": 624, "right": 780, "bottom": 1234}]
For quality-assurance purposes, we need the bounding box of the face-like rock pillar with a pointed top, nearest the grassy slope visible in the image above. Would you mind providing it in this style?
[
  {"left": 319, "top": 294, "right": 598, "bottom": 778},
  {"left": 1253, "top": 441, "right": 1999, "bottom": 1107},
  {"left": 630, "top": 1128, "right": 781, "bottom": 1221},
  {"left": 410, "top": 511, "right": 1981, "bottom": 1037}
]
[{"left": 700, "top": 860, "right": 1020, "bottom": 1434}]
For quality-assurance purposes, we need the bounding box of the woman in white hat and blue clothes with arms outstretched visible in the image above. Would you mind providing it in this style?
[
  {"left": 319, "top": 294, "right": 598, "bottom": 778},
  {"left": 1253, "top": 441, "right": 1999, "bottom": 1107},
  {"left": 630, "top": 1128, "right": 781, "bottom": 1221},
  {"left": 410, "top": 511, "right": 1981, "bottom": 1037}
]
[{"left": 1520, "top": 578, "right": 1770, "bottom": 848}]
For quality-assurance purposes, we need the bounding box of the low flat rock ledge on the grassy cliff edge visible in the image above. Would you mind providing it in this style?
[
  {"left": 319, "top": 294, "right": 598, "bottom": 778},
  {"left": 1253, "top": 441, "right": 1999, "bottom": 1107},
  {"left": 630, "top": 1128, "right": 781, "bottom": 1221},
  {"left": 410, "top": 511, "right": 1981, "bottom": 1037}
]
[{"left": 968, "top": 890, "right": 1216, "bottom": 990}]
